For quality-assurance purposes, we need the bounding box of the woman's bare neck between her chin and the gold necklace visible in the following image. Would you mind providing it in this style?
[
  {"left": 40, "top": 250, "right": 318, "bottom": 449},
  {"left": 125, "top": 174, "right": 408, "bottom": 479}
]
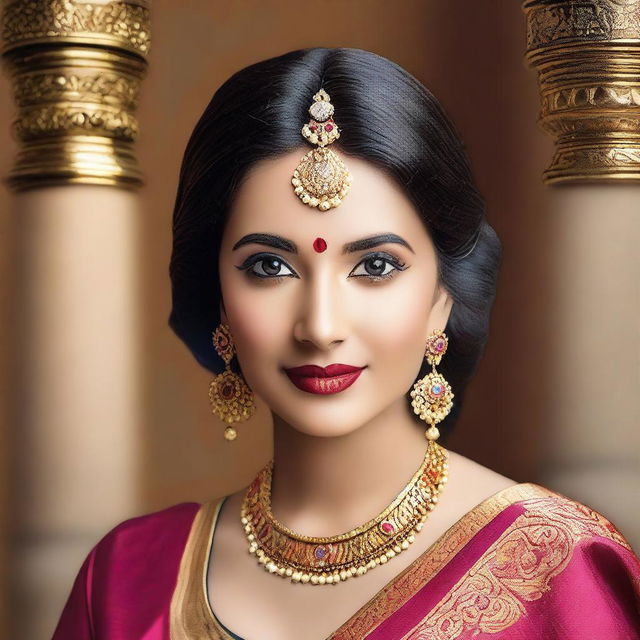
[{"left": 271, "top": 398, "right": 427, "bottom": 536}]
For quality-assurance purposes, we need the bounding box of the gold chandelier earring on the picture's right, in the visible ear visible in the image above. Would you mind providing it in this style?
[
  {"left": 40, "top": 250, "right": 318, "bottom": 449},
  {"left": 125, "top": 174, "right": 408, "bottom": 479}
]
[{"left": 411, "top": 329, "right": 454, "bottom": 441}]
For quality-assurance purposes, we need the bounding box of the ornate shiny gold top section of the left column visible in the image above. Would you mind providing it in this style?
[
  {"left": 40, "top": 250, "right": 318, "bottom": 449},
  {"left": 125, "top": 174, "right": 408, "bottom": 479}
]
[{"left": 3, "top": 0, "right": 149, "bottom": 190}]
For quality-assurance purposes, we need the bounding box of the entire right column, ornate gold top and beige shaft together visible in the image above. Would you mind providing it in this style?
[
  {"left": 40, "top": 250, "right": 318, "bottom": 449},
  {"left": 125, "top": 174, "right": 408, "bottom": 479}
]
[{"left": 523, "top": 0, "right": 640, "bottom": 548}]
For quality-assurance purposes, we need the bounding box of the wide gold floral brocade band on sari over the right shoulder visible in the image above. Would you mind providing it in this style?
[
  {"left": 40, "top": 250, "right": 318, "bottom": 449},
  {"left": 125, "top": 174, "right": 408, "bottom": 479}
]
[{"left": 402, "top": 497, "right": 630, "bottom": 640}]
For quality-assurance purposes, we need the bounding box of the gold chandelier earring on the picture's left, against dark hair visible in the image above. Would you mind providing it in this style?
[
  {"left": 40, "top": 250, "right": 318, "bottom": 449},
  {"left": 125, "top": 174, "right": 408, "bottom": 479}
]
[{"left": 209, "top": 323, "right": 256, "bottom": 440}]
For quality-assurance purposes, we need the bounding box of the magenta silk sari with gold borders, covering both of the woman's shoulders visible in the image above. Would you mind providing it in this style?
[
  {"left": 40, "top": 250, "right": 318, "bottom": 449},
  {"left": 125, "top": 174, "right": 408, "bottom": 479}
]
[{"left": 53, "top": 484, "right": 640, "bottom": 640}]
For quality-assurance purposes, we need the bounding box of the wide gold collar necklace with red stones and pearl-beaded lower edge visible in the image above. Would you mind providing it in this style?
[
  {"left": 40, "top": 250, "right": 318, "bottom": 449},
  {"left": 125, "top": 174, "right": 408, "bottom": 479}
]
[{"left": 241, "top": 441, "right": 448, "bottom": 584}]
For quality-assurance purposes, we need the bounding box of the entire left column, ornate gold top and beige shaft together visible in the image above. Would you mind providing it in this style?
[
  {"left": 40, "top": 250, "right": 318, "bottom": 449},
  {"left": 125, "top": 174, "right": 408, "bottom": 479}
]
[{"left": 2, "top": 0, "right": 149, "bottom": 638}]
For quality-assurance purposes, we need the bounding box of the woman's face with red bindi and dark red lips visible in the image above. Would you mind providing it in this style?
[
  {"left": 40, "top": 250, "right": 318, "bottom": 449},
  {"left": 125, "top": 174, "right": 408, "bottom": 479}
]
[{"left": 219, "top": 150, "right": 451, "bottom": 436}]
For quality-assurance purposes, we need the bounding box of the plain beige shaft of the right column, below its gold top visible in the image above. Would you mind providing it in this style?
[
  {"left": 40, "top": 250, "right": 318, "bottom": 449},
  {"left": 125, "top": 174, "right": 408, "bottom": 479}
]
[{"left": 545, "top": 184, "right": 640, "bottom": 550}]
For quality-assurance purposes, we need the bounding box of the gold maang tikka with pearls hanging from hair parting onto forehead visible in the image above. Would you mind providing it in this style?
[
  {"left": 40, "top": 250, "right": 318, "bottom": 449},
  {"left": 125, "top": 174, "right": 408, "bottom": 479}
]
[{"left": 291, "top": 89, "right": 353, "bottom": 211}]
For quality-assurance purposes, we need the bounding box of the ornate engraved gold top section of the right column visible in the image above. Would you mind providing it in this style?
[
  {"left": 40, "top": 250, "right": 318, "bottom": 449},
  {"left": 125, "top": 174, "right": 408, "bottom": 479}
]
[{"left": 523, "top": 0, "right": 640, "bottom": 184}]
